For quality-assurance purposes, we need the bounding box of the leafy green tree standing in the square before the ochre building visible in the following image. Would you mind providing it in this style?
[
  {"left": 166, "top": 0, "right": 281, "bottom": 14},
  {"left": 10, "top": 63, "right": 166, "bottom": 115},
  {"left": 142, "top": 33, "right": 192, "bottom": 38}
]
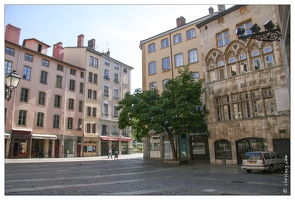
[{"left": 117, "top": 66, "right": 208, "bottom": 160}]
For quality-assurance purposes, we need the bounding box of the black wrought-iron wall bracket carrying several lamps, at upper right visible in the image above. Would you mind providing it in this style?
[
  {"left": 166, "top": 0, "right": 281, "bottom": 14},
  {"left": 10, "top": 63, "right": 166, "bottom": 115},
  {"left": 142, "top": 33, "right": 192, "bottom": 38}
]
[{"left": 236, "top": 20, "right": 281, "bottom": 42}]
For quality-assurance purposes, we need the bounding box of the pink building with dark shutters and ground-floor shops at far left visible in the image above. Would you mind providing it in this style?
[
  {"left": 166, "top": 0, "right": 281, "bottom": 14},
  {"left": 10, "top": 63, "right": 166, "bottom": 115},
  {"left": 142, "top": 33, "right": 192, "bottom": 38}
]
[{"left": 4, "top": 24, "right": 85, "bottom": 158}]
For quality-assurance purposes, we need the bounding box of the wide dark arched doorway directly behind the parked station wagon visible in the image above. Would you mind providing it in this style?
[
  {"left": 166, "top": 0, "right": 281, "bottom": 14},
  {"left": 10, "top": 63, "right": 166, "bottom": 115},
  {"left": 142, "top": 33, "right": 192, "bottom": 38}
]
[{"left": 236, "top": 138, "right": 267, "bottom": 164}]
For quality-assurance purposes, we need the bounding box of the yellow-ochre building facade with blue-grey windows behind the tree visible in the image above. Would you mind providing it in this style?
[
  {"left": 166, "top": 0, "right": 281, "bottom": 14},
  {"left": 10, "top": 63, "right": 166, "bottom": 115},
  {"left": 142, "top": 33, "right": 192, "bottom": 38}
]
[{"left": 139, "top": 6, "right": 225, "bottom": 160}]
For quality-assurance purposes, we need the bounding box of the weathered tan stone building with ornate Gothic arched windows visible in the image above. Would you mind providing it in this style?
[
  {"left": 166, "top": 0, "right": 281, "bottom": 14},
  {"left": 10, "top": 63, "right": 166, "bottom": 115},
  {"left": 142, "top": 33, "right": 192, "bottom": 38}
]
[{"left": 197, "top": 5, "right": 290, "bottom": 164}]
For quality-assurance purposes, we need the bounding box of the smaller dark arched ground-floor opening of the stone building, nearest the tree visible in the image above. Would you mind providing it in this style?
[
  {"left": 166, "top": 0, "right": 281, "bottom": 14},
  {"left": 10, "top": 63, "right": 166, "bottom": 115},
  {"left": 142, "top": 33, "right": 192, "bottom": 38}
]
[{"left": 214, "top": 140, "right": 232, "bottom": 160}]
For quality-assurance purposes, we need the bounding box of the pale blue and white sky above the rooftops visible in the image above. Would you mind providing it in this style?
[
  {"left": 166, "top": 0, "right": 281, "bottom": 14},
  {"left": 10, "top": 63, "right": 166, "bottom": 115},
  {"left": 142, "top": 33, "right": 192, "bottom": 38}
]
[{"left": 3, "top": 0, "right": 237, "bottom": 93}]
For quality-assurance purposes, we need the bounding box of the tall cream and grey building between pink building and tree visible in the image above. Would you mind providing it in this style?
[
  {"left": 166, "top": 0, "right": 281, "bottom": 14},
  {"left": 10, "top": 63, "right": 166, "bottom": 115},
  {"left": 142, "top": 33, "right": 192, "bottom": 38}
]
[{"left": 60, "top": 35, "right": 133, "bottom": 156}]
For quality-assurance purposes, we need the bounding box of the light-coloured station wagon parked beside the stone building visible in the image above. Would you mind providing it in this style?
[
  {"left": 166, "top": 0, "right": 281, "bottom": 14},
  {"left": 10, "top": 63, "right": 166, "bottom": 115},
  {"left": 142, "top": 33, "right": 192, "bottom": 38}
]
[{"left": 241, "top": 151, "right": 285, "bottom": 173}]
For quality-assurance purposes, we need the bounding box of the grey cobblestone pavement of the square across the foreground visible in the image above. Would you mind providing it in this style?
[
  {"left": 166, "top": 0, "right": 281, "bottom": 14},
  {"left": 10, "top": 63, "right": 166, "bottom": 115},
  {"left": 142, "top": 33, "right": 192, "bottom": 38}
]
[{"left": 5, "top": 155, "right": 291, "bottom": 196}]
